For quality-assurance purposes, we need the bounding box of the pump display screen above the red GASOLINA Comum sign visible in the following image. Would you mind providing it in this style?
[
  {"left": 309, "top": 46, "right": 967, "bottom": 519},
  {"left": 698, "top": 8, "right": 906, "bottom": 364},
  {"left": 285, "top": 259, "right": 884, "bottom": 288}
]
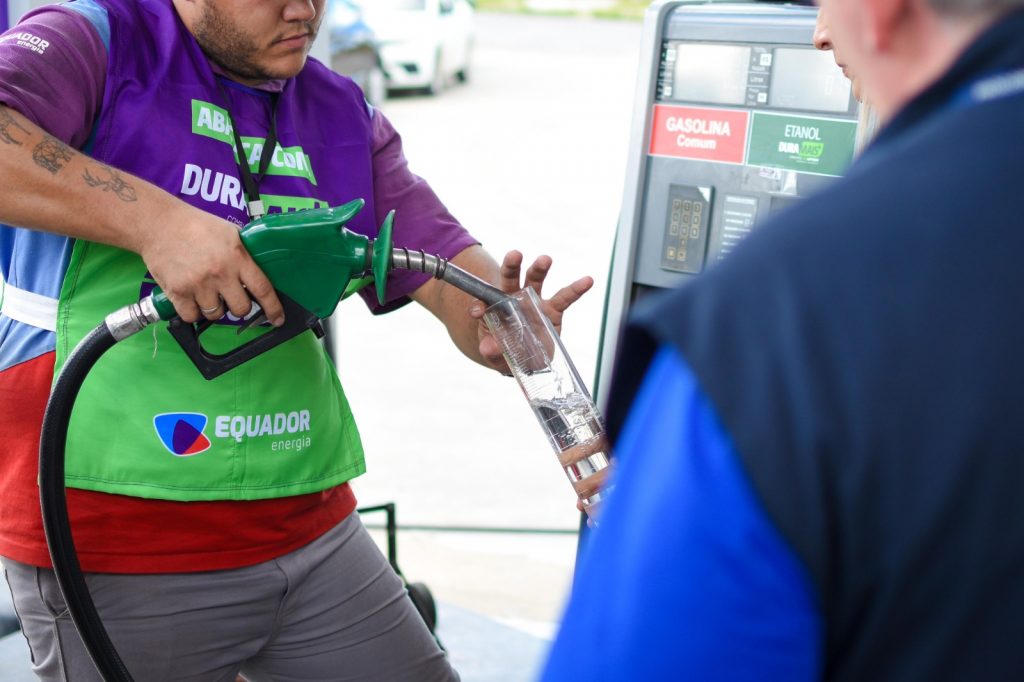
[{"left": 672, "top": 43, "right": 751, "bottom": 105}]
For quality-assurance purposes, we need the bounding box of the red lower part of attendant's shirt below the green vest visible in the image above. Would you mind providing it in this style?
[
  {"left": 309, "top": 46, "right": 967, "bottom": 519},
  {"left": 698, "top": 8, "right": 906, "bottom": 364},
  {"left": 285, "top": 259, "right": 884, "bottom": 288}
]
[{"left": 0, "top": 352, "right": 355, "bottom": 573}]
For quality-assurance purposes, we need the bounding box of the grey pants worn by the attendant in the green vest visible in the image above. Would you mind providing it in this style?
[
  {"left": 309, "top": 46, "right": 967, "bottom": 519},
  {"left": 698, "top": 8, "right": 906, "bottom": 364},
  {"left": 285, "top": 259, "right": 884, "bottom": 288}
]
[{"left": 3, "top": 514, "right": 459, "bottom": 682}]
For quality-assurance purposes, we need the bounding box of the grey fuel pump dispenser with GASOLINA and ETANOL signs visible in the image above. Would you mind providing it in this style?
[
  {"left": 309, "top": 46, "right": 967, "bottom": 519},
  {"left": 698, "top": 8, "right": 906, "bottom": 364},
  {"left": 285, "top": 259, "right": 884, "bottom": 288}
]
[{"left": 597, "top": 0, "right": 859, "bottom": 402}]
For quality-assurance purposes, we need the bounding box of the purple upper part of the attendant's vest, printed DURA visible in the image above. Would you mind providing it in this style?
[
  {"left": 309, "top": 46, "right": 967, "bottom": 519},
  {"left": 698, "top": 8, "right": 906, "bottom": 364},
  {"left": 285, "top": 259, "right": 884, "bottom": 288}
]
[{"left": 90, "top": 0, "right": 377, "bottom": 231}]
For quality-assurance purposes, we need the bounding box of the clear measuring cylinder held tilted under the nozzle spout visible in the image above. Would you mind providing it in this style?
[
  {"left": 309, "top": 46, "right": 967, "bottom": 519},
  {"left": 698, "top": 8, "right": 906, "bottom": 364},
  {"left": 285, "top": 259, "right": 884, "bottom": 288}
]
[{"left": 483, "top": 288, "right": 608, "bottom": 518}]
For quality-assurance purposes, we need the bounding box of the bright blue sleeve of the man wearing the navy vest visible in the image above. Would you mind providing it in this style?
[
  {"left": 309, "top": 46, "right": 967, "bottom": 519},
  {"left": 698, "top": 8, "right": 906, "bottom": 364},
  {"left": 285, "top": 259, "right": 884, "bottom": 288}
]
[{"left": 543, "top": 347, "right": 822, "bottom": 682}]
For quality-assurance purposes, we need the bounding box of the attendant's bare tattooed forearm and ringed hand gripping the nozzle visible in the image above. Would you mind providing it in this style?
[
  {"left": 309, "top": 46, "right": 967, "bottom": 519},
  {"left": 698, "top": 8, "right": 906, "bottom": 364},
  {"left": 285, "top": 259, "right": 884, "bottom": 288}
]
[{"left": 0, "top": 105, "right": 283, "bottom": 323}]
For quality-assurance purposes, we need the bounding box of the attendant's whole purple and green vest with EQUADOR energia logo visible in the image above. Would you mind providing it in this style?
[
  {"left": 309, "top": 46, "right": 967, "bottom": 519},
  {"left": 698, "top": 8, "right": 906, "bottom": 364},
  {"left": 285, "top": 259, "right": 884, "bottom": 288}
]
[{"left": 48, "top": 0, "right": 376, "bottom": 501}]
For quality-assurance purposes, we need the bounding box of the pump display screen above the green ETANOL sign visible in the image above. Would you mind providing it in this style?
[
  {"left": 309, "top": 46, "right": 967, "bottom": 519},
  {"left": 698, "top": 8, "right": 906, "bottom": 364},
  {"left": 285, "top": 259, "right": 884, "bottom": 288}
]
[{"left": 768, "top": 47, "right": 850, "bottom": 114}]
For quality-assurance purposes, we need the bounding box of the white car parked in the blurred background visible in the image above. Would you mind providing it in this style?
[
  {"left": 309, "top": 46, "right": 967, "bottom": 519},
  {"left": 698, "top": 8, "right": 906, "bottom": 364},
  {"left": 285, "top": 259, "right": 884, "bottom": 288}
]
[{"left": 362, "top": 0, "right": 473, "bottom": 94}]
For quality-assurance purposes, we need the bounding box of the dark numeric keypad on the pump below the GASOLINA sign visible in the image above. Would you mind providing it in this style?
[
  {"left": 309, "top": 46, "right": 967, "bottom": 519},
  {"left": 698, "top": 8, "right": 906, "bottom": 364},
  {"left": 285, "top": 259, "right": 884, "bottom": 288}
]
[{"left": 662, "top": 184, "right": 712, "bottom": 274}]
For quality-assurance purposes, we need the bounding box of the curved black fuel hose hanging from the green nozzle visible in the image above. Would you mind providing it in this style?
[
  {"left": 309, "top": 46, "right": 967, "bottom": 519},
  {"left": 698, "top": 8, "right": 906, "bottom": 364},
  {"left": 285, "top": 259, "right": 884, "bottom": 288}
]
[{"left": 39, "top": 323, "right": 132, "bottom": 682}]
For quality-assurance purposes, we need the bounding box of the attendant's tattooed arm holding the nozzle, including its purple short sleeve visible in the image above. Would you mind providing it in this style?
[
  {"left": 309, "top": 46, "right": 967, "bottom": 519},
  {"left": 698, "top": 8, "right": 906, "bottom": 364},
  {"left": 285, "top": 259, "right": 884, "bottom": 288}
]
[{"left": 0, "top": 9, "right": 281, "bottom": 322}]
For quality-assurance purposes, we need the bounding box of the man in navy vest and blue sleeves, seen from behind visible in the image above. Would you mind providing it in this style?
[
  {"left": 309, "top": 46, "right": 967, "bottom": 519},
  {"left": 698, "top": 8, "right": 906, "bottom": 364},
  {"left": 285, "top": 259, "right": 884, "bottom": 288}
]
[{"left": 544, "top": 0, "right": 1024, "bottom": 681}]
